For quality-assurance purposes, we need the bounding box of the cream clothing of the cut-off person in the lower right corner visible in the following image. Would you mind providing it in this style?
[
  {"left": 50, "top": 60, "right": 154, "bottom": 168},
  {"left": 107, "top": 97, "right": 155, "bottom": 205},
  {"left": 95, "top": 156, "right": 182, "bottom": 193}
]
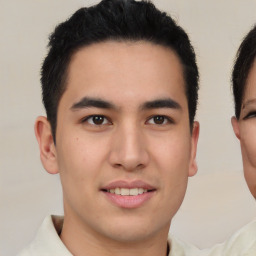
[{"left": 201, "top": 219, "right": 256, "bottom": 256}]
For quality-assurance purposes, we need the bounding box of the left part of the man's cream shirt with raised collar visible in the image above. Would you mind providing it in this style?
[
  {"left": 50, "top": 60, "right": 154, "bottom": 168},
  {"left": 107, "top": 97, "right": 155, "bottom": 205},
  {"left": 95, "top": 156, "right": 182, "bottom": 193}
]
[{"left": 18, "top": 216, "right": 72, "bottom": 256}]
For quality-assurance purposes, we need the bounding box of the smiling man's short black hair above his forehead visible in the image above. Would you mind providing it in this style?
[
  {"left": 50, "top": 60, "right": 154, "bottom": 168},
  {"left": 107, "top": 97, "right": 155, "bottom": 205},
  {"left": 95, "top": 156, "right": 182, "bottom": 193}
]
[{"left": 41, "top": 0, "right": 199, "bottom": 140}]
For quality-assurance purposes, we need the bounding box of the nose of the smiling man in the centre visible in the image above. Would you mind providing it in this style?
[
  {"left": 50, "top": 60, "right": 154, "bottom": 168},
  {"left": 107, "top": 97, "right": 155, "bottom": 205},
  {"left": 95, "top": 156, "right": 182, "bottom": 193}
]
[{"left": 109, "top": 125, "right": 149, "bottom": 171}]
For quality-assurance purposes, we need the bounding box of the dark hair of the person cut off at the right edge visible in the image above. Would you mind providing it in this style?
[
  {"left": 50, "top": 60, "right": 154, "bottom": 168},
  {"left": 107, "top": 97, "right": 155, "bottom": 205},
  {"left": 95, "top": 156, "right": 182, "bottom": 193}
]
[{"left": 232, "top": 25, "right": 256, "bottom": 119}]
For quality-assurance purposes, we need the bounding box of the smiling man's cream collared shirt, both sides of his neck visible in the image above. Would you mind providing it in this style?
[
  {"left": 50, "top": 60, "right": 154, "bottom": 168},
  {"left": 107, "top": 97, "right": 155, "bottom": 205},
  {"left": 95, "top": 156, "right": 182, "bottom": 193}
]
[{"left": 18, "top": 216, "right": 199, "bottom": 256}]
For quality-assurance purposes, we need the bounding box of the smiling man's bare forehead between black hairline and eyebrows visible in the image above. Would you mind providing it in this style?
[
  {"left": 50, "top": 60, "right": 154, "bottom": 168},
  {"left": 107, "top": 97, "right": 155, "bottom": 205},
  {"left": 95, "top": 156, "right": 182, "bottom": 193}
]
[{"left": 64, "top": 41, "right": 185, "bottom": 107}]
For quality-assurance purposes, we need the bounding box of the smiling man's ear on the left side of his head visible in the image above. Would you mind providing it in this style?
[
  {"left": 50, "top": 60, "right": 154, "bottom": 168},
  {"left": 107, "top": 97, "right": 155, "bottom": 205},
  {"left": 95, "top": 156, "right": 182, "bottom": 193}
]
[{"left": 35, "top": 116, "right": 59, "bottom": 174}]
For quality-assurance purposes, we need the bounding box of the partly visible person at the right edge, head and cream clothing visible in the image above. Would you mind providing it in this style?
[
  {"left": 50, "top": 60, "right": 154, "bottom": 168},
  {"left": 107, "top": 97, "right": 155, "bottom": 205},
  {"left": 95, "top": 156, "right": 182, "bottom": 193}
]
[{"left": 204, "top": 26, "right": 256, "bottom": 256}]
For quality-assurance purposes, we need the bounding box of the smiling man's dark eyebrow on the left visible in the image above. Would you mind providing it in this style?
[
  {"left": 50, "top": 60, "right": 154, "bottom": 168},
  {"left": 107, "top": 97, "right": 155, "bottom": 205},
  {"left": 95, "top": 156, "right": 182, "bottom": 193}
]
[{"left": 71, "top": 97, "right": 116, "bottom": 110}]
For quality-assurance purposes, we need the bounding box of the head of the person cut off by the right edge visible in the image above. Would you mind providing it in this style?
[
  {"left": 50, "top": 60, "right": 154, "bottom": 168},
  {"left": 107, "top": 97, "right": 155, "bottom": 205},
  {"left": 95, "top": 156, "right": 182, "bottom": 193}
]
[{"left": 232, "top": 26, "right": 256, "bottom": 198}]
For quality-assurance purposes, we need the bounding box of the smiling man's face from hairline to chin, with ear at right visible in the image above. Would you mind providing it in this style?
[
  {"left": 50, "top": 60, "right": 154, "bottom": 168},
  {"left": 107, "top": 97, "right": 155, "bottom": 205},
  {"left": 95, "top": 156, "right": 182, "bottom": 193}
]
[{"left": 38, "top": 42, "right": 198, "bottom": 241}]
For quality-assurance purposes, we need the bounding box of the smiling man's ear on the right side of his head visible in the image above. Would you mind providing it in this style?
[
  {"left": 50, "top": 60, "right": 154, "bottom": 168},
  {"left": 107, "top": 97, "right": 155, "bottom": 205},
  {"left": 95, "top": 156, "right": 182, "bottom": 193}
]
[{"left": 188, "top": 121, "right": 200, "bottom": 177}]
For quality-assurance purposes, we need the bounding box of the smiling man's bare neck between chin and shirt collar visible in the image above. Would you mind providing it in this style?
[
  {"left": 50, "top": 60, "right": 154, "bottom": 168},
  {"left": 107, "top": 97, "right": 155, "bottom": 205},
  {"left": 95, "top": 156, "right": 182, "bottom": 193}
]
[{"left": 60, "top": 217, "right": 168, "bottom": 256}]
